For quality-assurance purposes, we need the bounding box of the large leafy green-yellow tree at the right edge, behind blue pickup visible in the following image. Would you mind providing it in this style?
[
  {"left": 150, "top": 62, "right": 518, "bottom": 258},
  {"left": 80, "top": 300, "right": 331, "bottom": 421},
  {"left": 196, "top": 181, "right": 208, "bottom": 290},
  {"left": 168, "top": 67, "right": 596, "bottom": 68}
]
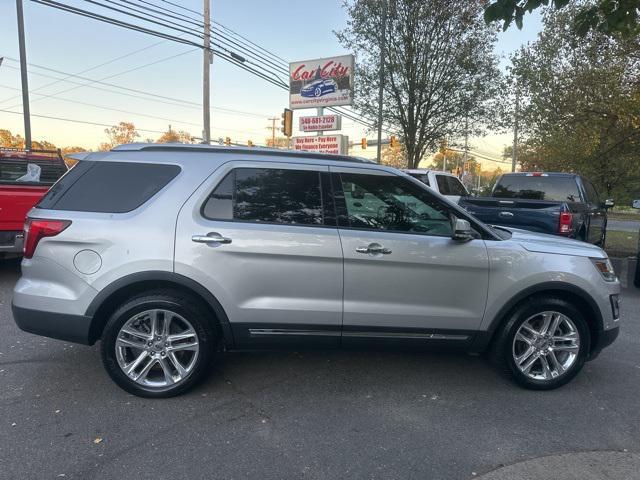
[{"left": 511, "top": 7, "right": 640, "bottom": 201}]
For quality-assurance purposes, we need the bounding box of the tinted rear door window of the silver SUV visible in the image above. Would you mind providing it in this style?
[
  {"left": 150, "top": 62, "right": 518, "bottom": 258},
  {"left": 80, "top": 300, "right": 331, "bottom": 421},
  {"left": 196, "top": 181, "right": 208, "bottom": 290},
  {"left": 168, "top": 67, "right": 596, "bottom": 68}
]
[{"left": 202, "top": 168, "right": 324, "bottom": 226}]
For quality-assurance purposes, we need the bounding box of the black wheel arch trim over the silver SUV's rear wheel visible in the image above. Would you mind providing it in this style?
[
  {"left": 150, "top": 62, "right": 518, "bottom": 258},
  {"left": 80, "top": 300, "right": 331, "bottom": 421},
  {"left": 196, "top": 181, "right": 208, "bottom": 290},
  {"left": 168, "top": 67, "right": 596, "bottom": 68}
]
[{"left": 86, "top": 271, "right": 234, "bottom": 346}]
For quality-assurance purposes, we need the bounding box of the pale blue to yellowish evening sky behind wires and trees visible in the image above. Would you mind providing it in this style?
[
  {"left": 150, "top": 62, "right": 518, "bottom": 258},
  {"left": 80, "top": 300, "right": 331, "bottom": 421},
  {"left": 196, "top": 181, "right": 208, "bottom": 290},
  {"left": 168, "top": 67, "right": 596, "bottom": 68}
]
[{"left": 0, "top": 0, "right": 541, "bottom": 169}]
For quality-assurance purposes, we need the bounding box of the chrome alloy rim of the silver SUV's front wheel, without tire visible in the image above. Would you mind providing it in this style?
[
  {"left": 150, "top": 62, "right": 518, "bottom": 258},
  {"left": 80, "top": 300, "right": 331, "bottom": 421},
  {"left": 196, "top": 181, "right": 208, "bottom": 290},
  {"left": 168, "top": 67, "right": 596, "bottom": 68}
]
[{"left": 512, "top": 311, "right": 580, "bottom": 381}]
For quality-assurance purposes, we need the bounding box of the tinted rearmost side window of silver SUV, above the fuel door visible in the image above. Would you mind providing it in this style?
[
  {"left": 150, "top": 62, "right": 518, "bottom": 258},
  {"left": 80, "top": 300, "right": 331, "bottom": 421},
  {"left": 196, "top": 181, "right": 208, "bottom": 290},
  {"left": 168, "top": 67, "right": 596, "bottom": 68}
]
[{"left": 38, "top": 161, "right": 180, "bottom": 213}]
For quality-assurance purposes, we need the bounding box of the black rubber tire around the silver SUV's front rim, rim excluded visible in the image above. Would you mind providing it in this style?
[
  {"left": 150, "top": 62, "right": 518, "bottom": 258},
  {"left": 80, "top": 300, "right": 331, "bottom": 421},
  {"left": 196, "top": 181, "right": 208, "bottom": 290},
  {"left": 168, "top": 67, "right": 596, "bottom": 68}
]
[{"left": 490, "top": 296, "right": 591, "bottom": 390}]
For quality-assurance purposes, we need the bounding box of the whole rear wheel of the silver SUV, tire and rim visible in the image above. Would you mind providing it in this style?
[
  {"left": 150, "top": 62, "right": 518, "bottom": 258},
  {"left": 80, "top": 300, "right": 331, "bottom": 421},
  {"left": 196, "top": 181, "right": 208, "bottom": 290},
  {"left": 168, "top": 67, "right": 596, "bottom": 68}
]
[{"left": 101, "top": 291, "right": 215, "bottom": 398}]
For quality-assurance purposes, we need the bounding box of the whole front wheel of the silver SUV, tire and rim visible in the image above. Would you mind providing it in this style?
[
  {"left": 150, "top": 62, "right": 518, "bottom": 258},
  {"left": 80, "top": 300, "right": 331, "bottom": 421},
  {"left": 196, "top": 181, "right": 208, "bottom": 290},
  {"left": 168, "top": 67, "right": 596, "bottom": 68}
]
[{"left": 494, "top": 296, "right": 590, "bottom": 390}]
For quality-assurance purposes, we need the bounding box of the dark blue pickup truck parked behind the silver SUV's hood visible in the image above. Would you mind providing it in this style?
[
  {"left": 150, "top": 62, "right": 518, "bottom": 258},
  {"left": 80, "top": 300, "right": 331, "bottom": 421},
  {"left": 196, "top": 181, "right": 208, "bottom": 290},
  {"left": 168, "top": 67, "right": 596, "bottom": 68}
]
[{"left": 460, "top": 172, "right": 614, "bottom": 247}]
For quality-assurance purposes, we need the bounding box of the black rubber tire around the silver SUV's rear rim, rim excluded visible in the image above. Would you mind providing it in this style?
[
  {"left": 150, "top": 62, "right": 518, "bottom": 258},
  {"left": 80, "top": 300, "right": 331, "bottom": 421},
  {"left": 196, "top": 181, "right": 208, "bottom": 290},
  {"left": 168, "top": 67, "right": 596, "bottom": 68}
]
[{"left": 100, "top": 290, "right": 219, "bottom": 398}]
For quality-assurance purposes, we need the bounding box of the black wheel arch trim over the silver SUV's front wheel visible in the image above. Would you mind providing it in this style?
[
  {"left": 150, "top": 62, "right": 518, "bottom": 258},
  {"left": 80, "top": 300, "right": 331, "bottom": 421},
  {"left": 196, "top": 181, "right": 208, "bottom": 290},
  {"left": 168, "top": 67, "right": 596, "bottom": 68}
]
[{"left": 473, "top": 282, "right": 604, "bottom": 352}]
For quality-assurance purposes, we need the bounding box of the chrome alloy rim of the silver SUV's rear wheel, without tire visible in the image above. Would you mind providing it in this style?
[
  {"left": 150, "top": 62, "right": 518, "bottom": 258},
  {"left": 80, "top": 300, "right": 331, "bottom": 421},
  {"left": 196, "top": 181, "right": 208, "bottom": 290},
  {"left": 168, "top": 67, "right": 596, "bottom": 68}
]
[{"left": 115, "top": 309, "right": 199, "bottom": 388}]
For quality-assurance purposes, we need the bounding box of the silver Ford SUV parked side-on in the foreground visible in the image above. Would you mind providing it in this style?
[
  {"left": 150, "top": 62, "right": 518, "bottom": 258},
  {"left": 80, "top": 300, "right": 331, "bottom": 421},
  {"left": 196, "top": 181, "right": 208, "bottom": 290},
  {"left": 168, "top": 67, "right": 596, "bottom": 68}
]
[{"left": 13, "top": 144, "right": 620, "bottom": 397}]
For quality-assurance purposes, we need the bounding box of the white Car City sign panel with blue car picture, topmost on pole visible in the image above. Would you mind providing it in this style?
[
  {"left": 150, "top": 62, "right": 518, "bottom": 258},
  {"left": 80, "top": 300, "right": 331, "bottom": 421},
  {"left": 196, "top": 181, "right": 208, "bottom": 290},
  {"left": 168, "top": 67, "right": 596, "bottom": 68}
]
[{"left": 289, "top": 55, "right": 354, "bottom": 109}]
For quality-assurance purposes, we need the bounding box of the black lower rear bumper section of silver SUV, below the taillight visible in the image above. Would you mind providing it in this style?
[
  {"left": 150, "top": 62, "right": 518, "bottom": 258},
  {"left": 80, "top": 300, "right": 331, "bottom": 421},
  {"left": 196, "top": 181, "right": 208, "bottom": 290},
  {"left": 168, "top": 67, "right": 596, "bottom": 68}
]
[{"left": 11, "top": 303, "right": 91, "bottom": 345}]
